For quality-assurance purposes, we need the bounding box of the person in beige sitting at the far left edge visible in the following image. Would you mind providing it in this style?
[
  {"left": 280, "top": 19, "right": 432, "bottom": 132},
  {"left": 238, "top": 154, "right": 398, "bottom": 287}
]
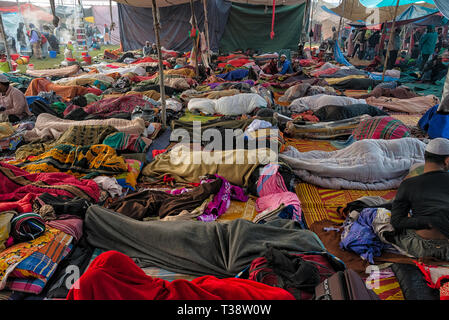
[{"left": 0, "top": 74, "right": 32, "bottom": 122}]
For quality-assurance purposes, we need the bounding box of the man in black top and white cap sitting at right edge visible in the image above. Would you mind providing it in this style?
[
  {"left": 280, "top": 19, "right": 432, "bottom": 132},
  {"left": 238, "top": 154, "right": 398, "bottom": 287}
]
[{"left": 385, "top": 138, "right": 449, "bottom": 261}]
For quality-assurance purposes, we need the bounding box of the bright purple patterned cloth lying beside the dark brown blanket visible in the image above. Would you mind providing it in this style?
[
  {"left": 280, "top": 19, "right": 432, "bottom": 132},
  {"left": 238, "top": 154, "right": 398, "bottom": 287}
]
[{"left": 197, "top": 175, "right": 248, "bottom": 222}]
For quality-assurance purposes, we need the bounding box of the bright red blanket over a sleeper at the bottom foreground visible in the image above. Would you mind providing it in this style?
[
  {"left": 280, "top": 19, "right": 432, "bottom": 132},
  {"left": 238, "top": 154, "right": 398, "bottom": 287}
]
[{"left": 67, "top": 251, "right": 294, "bottom": 300}]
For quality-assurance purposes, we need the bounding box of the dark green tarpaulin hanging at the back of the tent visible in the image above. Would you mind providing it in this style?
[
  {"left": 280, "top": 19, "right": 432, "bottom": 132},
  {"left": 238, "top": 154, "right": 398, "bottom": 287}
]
[{"left": 220, "top": 3, "right": 305, "bottom": 52}]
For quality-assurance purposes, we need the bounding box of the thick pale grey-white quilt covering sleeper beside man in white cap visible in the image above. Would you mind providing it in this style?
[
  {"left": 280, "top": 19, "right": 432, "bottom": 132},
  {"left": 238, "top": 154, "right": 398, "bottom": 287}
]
[{"left": 279, "top": 138, "right": 426, "bottom": 190}]
